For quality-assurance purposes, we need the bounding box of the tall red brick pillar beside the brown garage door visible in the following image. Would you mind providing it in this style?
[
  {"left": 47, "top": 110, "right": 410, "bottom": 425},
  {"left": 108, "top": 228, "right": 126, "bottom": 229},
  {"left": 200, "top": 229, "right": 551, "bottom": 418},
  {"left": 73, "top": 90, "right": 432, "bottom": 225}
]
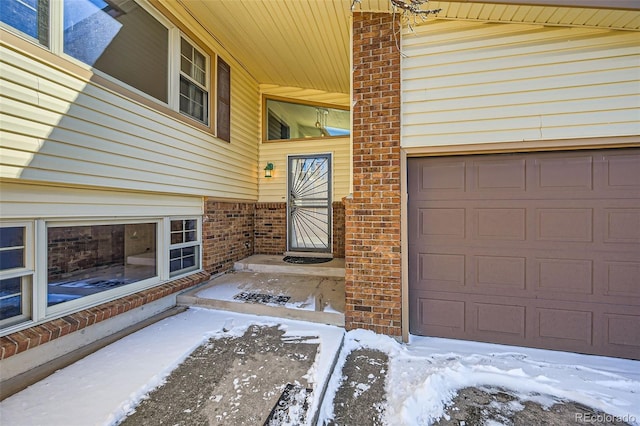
[{"left": 345, "top": 12, "right": 402, "bottom": 336}]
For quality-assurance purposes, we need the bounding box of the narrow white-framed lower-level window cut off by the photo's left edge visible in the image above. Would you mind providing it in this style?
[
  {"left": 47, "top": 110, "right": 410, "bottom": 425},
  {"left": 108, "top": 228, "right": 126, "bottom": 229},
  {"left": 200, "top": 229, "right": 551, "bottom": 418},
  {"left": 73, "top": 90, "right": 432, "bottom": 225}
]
[{"left": 0, "top": 224, "right": 34, "bottom": 327}]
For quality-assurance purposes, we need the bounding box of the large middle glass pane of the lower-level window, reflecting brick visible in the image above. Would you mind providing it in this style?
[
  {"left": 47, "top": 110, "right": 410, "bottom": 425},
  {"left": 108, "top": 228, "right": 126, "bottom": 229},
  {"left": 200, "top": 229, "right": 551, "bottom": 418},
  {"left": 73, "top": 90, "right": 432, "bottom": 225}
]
[{"left": 47, "top": 223, "right": 158, "bottom": 307}]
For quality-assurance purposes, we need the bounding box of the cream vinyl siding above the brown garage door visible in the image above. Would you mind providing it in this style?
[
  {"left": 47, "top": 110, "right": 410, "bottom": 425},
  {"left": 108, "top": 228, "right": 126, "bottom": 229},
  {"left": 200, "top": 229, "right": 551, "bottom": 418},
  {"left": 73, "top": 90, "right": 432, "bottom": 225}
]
[{"left": 402, "top": 20, "right": 640, "bottom": 148}]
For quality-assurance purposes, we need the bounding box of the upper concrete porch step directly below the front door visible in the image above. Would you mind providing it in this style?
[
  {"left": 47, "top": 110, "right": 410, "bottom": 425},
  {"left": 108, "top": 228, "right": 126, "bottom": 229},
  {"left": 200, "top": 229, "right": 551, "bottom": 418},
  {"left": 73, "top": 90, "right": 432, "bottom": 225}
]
[{"left": 234, "top": 254, "right": 344, "bottom": 278}]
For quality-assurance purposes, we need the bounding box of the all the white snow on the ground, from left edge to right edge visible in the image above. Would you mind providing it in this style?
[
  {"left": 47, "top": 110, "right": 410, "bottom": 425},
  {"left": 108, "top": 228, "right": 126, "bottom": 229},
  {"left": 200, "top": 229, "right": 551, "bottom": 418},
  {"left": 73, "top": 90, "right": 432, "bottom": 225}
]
[{"left": 0, "top": 308, "right": 640, "bottom": 426}]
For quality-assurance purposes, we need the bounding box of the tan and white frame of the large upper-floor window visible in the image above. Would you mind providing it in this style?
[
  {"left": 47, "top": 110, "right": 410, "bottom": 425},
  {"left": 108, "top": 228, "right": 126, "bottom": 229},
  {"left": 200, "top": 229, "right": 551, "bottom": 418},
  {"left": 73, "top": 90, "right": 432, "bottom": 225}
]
[{"left": 0, "top": 0, "right": 219, "bottom": 137}]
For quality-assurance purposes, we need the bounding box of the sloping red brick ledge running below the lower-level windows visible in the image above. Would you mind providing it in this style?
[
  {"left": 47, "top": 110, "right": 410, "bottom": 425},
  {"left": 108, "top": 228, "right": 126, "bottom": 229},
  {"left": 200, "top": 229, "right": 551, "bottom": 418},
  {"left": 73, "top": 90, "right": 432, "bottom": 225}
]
[{"left": 0, "top": 272, "right": 210, "bottom": 360}]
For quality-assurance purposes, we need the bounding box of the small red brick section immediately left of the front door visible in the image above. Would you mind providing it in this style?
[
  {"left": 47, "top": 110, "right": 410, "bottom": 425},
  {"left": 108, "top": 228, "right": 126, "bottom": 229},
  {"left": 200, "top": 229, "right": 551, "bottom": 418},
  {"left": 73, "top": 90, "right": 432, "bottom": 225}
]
[{"left": 254, "top": 203, "right": 287, "bottom": 255}]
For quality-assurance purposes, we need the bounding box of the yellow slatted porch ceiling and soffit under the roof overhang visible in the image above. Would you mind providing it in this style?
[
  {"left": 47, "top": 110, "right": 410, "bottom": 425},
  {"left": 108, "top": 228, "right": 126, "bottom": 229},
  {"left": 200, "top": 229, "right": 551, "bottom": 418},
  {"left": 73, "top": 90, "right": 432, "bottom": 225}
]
[{"left": 170, "top": 0, "right": 640, "bottom": 93}]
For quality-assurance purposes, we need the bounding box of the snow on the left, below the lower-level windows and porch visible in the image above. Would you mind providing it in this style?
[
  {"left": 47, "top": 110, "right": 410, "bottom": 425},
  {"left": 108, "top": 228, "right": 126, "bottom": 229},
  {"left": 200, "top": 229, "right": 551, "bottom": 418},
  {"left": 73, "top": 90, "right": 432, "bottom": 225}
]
[{"left": 0, "top": 308, "right": 344, "bottom": 426}]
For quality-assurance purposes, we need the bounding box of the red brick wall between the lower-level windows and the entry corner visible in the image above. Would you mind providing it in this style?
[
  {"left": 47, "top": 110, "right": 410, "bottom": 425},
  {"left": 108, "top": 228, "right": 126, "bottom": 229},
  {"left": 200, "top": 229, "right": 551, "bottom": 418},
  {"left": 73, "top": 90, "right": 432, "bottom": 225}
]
[{"left": 202, "top": 199, "right": 255, "bottom": 274}]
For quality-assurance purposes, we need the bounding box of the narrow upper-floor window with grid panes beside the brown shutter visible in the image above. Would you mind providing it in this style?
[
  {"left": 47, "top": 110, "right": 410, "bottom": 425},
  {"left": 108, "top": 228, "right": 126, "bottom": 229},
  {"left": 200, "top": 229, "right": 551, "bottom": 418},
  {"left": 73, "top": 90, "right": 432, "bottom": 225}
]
[{"left": 180, "top": 37, "right": 209, "bottom": 124}]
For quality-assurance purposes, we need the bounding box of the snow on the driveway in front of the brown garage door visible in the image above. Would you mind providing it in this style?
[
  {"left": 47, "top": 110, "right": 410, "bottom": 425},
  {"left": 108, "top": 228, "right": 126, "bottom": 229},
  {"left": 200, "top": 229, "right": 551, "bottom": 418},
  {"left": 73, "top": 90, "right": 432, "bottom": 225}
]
[{"left": 320, "top": 330, "right": 640, "bottom": 425}]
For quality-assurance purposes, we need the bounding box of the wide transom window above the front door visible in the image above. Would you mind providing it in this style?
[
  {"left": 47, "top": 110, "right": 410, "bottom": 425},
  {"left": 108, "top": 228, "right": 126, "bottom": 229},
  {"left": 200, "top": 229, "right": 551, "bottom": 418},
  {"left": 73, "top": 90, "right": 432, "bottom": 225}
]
[{"left": 263, "top": 98, "right": 351, "bottom": 141}]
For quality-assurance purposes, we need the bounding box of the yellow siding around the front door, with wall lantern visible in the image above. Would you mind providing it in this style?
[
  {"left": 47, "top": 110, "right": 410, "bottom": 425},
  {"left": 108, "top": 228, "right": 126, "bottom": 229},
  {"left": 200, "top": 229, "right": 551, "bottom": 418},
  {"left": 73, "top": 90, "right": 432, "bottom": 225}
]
[{"left": 258, "top": 138, "right": 351, "bottom": 202}]
